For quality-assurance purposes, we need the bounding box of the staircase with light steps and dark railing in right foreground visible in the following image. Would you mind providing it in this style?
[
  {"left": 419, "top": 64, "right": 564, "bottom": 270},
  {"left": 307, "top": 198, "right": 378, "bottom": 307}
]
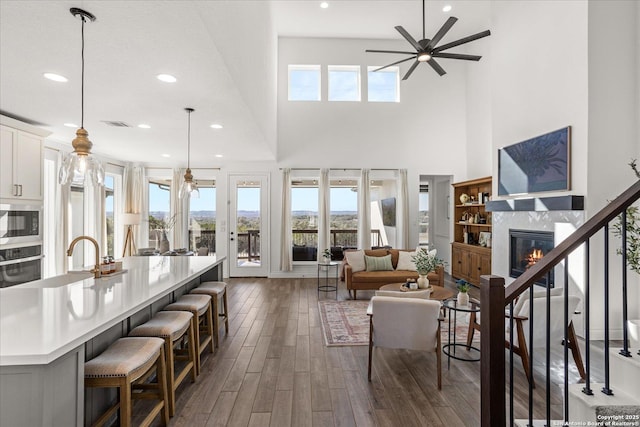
[{"left": 480, "top": 180, "right": 640, "bottom": 427}]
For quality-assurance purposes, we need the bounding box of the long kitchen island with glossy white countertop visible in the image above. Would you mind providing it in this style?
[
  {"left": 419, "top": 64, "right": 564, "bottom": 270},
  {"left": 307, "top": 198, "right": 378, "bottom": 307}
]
[{"left": 0, "top": 256, "right": 224, "bottom": 427}]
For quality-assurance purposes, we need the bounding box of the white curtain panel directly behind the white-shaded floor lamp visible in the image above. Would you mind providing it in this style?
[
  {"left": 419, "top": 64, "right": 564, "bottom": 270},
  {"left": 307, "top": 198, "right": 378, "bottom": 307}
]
[{"left": 121, "top": 165, "right": 149, "bottom": 248}]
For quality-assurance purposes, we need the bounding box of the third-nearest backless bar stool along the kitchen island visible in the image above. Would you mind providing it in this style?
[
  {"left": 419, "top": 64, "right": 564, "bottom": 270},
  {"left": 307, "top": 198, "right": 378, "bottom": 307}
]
[{"left": 163, "top": 295, "right": 215, "bottom": 375}]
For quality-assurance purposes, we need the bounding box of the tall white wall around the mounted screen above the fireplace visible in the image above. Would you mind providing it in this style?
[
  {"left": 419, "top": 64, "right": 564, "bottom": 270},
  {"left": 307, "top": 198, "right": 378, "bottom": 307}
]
[{"left": 484, "top": 1, "right": 640, "bottom": 339}]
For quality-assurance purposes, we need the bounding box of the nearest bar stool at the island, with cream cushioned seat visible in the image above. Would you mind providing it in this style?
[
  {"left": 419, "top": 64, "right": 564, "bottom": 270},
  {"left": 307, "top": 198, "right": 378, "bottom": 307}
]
[{"left": 84, "top": 338, "right": 169, "bottom": 427}]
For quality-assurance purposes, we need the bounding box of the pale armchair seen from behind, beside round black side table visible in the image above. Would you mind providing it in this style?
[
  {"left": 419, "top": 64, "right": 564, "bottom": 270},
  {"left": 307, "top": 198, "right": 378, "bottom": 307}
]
[{"left": 368, "top": 296, "right": 442, "bottom": 390}]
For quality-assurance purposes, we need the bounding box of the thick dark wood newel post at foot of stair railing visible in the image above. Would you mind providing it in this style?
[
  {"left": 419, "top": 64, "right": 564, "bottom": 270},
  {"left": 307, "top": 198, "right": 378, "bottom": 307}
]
[{"left": 480, "top": 276, "right": 506, "bottom": 427}]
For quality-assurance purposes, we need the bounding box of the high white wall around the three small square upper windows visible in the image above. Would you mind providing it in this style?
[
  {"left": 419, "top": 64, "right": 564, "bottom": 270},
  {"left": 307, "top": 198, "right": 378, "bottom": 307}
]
[{"left": 278, "top": 38, "right": 468, "bottom": 175}]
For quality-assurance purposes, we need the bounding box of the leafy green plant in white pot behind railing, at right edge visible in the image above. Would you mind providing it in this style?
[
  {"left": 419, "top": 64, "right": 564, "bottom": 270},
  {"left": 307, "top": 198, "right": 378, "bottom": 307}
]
[{"left": 613, "top": 159, "right": 640, "bottom": 345}]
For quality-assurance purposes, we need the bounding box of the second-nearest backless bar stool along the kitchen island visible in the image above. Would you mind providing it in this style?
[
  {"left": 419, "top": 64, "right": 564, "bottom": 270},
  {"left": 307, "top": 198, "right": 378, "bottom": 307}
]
[{"left": 129, "top": 311, "right": 196, "bottom": 416}]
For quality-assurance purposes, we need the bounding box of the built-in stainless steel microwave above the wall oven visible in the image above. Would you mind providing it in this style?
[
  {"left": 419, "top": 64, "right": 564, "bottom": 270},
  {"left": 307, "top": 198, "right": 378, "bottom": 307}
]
[{"left": 0, "top": 204, "right": 42, "bottom": 245}]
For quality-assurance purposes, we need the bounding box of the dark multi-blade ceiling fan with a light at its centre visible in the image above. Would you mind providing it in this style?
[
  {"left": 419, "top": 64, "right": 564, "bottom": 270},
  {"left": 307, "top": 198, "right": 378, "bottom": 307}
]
[{"left": 365, "top": 0, "right": 491, "bottom": 80}]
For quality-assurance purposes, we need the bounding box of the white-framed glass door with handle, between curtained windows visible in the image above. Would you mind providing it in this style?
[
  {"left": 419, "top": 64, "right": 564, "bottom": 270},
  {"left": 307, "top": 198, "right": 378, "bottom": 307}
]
[{"left": 229, "top": 174, "right": 269, "bottom": 277}]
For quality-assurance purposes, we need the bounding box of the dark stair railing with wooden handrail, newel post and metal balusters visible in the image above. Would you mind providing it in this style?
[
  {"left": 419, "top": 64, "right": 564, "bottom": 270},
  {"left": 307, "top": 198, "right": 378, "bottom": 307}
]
[{"left": 480, "top": 181, "right": 640, "bottom": 427}]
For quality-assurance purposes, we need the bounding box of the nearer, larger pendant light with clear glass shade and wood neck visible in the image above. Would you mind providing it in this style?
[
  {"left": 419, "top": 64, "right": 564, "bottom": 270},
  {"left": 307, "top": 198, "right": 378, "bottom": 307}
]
[{"left": 58, "top": 7, "right": 104, "bottom": 186}]
